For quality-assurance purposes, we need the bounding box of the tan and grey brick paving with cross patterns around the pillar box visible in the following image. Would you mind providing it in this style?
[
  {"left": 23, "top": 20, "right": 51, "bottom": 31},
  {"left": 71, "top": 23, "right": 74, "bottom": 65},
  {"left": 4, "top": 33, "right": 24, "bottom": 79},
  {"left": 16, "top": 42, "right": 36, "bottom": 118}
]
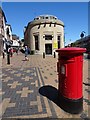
[{"left": 0, "top": 53, "right": 90, "bottom": 120}]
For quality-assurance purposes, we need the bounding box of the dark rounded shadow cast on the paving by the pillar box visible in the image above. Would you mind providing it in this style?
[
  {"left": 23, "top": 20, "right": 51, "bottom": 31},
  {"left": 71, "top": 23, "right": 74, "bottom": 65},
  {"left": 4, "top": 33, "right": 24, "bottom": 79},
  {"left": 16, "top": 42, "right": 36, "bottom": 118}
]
[{"left": 39, "top": 85, "right": 59, "bottom": 106}]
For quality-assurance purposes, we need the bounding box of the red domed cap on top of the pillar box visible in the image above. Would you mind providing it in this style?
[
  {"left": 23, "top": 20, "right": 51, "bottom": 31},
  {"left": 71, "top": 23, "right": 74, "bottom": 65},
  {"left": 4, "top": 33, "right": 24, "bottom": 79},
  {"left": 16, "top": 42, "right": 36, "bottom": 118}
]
[{"left": 56, "top": 47, "right": 86, "bottom": 55}]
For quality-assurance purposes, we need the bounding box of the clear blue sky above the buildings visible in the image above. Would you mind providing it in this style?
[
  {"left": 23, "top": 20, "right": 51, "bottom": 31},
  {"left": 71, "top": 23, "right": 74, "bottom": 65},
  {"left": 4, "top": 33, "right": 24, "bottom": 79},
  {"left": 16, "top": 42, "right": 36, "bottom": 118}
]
[{"left": 2, "top": 2, "right": 89, "bottom": 45}]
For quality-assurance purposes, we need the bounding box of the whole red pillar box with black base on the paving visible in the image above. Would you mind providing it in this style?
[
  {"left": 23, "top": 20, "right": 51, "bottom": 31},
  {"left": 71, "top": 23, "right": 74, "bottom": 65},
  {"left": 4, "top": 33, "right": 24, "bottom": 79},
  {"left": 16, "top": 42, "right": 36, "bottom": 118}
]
[{"left": 56, "top": 47, "right": 86, "bottom": 114}]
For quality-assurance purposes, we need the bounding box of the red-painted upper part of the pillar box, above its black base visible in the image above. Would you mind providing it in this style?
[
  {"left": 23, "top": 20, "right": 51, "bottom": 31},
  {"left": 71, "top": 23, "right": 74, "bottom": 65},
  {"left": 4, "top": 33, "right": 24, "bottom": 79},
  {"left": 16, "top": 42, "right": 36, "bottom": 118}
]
[{"left": 56, "top": 47, "right": 86, "bottom": 99}]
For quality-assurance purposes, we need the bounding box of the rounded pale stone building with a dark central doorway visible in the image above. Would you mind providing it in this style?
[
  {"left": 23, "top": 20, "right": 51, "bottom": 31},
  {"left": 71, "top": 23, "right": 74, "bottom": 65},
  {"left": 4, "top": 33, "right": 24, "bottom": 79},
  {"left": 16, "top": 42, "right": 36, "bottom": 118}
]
[{"left": 24, "top": 15, "right": 64, "bottom": 54}]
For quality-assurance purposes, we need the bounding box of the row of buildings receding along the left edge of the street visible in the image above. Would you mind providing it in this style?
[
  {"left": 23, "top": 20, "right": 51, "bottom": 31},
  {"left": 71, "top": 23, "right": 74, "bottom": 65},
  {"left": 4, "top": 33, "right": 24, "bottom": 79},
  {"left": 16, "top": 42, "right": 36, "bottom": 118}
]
[{"left": 0, "top": 7, "right": 20, "bottom": 56}]
